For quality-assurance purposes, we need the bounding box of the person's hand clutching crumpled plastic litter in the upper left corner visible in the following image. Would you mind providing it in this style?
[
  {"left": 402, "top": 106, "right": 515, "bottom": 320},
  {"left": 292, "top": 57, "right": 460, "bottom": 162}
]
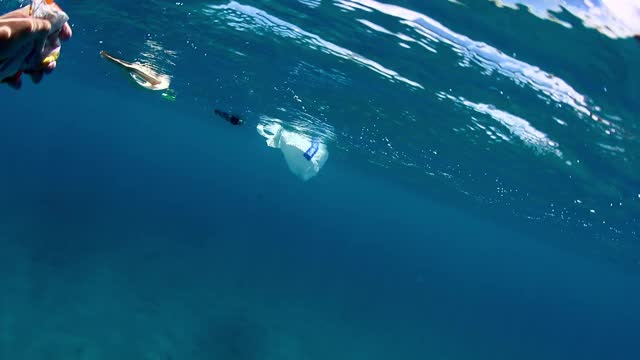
[{"left": 0, "top": 6, "right": 72, "bottom": 88}]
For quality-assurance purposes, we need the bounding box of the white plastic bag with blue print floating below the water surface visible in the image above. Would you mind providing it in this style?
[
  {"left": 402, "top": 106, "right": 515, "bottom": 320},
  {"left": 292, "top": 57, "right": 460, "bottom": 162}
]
[{"left": 257, "top": 123, "right": 329, "bottom": 181}]
